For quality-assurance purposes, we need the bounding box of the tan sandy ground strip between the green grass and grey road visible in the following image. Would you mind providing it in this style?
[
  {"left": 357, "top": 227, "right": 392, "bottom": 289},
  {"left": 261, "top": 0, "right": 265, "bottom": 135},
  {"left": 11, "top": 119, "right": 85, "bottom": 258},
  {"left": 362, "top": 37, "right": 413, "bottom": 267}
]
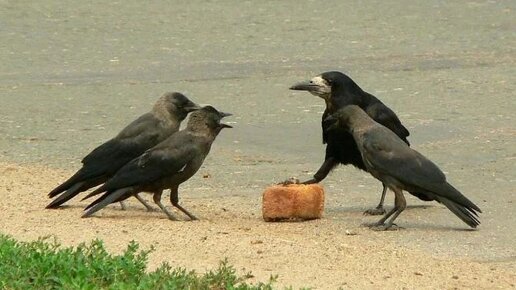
[{"left": 0, "top": 163, "right": 516, "bottom": 289}]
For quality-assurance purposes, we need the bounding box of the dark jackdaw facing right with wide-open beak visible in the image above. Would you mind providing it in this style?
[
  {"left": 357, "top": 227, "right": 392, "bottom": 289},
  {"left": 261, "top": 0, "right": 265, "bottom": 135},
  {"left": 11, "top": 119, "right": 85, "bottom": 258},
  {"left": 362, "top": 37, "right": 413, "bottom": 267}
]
[{"left": 82, "top": 106, "right": 231, "bottom": 220}]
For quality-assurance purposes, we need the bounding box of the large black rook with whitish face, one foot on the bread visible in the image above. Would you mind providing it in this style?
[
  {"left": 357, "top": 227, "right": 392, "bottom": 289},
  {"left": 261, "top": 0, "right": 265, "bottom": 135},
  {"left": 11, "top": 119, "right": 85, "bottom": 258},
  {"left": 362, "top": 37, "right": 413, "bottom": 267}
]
[{"left": 290, "top": 71, "right": 430, "bottom": 215}]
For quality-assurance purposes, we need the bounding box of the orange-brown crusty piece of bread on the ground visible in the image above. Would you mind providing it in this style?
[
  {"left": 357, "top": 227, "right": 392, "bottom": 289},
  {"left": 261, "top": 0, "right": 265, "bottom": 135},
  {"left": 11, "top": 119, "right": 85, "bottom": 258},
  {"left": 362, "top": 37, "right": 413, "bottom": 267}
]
[{"left": 262, "top": 184, "right": 324, "bottom": 222}]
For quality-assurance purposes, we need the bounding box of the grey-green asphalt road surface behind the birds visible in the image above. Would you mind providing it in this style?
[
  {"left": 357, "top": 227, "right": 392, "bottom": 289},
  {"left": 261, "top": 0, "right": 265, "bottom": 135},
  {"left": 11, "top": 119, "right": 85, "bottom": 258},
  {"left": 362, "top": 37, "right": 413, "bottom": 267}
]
[{"left": 0, "top": 0, "right": 516, "bottom": 263}]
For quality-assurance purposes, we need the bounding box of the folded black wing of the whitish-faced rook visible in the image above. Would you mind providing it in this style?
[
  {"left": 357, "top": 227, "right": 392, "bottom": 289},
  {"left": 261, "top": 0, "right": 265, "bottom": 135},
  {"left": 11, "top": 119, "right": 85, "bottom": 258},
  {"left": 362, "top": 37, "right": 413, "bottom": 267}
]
[{"left": 365, "top": 102, "right": 410, "bottom": 145}]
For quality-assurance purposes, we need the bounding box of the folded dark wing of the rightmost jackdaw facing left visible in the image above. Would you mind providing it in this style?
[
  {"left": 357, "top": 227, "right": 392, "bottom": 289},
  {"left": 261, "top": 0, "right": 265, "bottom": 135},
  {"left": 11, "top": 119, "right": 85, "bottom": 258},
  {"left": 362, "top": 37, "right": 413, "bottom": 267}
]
[{"left": 362, "top": 126, "right": 480, "bottom": 211}]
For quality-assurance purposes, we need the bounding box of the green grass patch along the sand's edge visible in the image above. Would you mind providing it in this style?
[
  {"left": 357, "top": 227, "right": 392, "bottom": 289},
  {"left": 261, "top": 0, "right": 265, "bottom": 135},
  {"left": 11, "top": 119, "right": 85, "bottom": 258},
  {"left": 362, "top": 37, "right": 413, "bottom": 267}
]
[{"left": 0, "top": 235, "right": 275, "bottom": 289}]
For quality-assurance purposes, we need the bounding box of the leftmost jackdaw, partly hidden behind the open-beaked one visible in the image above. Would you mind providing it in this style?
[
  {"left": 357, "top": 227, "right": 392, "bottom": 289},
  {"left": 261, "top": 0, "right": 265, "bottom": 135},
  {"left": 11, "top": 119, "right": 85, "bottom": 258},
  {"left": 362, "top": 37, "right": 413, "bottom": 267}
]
[{"left": 46, "top": 92, "right": 200, "bottom": 210}]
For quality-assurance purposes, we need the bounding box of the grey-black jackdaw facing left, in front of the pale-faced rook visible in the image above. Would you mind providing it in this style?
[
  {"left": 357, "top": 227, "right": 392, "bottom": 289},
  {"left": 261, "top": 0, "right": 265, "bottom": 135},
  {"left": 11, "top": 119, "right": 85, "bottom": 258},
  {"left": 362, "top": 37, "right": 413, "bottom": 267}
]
[{"left": 326, "top": 105, "right": 482, "bottom": 230}]
